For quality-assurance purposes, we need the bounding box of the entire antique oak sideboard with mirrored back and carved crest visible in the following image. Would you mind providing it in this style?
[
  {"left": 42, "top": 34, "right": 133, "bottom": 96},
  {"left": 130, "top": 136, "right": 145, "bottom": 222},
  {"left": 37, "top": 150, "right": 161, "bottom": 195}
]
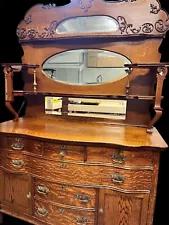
[{"left": 0, "top": 0, "right": 169, "bottom": 225}]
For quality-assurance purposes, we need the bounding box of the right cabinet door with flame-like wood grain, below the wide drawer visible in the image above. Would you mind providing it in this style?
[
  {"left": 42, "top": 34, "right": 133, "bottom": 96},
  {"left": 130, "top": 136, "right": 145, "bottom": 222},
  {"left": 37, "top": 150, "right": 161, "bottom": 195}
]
[{"left": 98, "top": 189, "right": 149, "bottom": 225}]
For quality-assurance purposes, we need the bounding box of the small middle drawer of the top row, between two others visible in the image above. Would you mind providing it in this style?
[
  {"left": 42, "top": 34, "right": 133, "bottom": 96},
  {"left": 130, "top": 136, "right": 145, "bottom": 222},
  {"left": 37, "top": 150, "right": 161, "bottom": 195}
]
[{"left": 44, "top": 143, "right": 84, "bottom": 162}]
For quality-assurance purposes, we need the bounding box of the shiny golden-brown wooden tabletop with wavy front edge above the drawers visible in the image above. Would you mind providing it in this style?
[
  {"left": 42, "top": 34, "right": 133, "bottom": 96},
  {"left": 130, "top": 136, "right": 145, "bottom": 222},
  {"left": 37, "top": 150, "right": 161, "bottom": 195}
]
[{"left": 0, "top": 116, "right": 167, "bottom": 150}]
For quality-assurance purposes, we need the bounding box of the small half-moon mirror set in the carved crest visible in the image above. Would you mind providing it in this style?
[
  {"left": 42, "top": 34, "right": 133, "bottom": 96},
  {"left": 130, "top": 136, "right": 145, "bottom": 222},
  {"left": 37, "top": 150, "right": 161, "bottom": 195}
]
[{"left": 56, "top": 16, "right": 119, "bottom": 34}]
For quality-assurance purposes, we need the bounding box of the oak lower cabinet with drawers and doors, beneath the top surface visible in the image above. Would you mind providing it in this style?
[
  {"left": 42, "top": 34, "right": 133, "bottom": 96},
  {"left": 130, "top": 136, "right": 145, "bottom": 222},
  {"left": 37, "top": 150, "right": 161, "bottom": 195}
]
[{"left": 0, "top": 125, "right": 165, "bottom": 225}]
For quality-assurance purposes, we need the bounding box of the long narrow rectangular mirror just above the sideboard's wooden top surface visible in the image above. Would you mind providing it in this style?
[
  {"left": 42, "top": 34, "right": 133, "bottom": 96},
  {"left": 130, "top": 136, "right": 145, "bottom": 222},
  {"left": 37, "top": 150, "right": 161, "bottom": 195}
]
[{"left": 45, "top": 96, "right": 127, "bottom": 120}]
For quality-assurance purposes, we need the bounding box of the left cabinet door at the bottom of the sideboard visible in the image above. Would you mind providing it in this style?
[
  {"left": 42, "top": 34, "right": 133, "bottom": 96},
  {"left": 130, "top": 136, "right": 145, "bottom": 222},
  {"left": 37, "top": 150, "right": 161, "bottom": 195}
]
[{"left": 1, "top": 172, "right": 32, "bottom": 215}]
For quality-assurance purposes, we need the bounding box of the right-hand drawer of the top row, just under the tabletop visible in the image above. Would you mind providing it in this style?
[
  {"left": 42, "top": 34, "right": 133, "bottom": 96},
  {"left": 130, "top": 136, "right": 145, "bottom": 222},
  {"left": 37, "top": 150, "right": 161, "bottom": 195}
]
[{"left": 87, "top": 147, "right": 153, "bottom": 168}]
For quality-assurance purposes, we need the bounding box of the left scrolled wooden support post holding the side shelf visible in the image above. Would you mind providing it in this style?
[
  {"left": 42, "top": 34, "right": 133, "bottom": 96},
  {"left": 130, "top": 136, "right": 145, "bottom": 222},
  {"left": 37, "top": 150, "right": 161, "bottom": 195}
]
[{"left": 4, "top": 66, "right": 19, "bottom": 121}]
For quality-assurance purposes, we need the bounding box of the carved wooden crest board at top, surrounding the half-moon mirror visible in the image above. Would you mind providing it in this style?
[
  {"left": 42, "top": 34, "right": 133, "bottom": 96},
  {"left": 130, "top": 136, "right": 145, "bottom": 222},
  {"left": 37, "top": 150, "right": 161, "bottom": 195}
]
[{"left": 17, "top": 0, "right": 168, "bottom": 42}]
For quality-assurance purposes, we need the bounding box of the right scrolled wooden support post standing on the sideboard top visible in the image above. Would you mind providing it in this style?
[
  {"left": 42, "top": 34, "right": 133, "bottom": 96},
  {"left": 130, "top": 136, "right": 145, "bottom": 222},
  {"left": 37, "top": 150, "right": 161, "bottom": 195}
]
[{"left": 147, "top": 67, "right": 168, "bottom": 133}]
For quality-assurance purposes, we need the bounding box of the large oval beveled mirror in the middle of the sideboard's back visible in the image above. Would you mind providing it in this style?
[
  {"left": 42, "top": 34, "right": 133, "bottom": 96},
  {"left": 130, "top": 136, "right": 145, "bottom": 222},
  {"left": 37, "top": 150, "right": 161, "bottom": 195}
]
[{"left": 42, "top": 49, "right": 131, "bottom": 85}]
